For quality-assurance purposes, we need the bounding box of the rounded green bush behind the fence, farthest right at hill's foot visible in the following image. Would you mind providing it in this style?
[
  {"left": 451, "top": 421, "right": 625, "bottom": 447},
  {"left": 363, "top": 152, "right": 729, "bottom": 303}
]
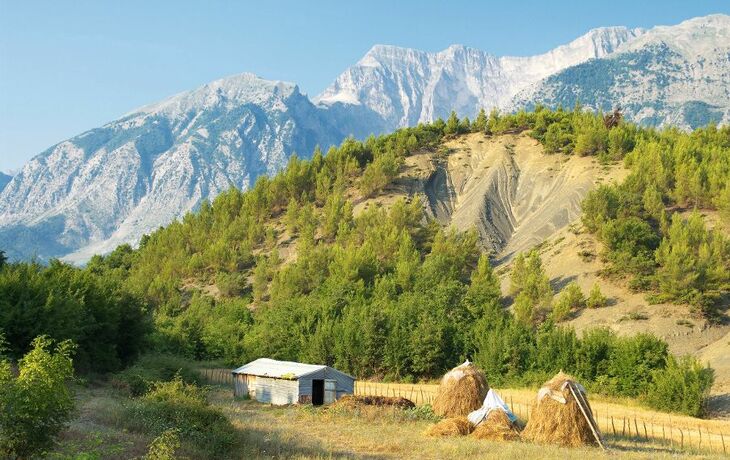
[{"left": 646, "top": 356, "right": 715, "bottom": 417}]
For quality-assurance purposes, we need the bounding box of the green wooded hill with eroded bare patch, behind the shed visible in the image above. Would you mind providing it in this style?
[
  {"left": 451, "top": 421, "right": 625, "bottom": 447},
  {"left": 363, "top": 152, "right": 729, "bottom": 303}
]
[{"left": 0, "top": 109, "right": 730, "bottom": 424}]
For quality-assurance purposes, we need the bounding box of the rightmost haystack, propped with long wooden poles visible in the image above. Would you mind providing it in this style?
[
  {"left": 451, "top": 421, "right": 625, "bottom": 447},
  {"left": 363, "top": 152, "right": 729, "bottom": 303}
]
[{"left": 522, "top": 372, "right": 597, "bottom": 447}]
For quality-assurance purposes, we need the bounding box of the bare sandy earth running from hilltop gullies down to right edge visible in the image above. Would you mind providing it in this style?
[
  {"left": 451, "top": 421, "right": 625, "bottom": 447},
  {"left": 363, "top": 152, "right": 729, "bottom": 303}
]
[{"left": 353, "top": 133, "right": 730, "bottom": 398}]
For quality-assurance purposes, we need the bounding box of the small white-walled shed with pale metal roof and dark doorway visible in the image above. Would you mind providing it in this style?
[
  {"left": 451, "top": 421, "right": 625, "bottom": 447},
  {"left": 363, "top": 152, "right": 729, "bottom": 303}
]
[{"left": 233, "top": 358, "right": 355, "bottom": 406}]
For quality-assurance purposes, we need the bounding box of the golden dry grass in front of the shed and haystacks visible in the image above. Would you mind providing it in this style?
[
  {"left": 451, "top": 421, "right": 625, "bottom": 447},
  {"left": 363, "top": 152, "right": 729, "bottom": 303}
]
[{"left": 213, "top": 391, "right": 720, "bottom": 460}]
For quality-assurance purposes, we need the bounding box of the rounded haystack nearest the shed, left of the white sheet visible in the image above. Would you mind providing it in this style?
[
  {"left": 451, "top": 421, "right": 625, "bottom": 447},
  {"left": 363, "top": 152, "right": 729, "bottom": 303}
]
[{"left": 433, "top": 361, "right": 489, "bottom": 417}]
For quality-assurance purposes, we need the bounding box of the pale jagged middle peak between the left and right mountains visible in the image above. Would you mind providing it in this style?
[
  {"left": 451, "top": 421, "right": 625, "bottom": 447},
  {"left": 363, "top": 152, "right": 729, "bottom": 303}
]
[{"left": 315, "top": 27, "right": 642, "bottom": 129}]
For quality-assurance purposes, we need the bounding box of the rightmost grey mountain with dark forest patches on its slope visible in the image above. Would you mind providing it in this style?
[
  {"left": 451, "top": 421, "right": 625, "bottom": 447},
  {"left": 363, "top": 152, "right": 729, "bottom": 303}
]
[{"left": 508, "top": 15, "right": 730, "bottom": 129}]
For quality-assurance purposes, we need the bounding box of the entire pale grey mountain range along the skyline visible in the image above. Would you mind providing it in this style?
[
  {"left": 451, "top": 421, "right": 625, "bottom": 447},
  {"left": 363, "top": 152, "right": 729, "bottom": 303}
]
[{"left": 0, "top": 15, "right": 730, "bottom": 262}]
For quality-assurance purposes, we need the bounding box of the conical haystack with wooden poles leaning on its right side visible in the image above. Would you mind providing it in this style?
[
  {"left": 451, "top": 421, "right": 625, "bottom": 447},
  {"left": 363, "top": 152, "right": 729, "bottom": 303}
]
[{"left": 522, "top": 372, "right": 600, "bottom": 447}]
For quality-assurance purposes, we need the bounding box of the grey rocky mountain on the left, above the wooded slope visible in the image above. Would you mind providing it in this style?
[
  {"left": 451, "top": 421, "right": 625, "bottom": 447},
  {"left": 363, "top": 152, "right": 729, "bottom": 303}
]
[{"left": 0, "top": 74, "right": 344, "bottom": 261}]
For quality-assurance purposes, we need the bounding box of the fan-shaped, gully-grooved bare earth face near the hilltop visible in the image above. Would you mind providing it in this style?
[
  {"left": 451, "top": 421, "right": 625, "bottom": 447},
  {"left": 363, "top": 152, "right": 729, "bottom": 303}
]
[{"left": 426, "top": 134, "right": 606, "bottom": 261}]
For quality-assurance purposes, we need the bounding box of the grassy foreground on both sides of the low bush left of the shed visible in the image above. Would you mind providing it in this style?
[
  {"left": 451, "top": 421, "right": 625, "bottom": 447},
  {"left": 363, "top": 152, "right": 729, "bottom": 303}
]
[{"left": 50, "top": 385, "right": 721, "bottom": 459}]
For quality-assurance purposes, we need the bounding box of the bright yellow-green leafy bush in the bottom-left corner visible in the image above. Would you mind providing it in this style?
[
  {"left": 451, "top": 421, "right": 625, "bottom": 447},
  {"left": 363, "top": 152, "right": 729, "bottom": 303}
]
[{"left": 0, "top": 336, "right": 74, "bottom": 458}]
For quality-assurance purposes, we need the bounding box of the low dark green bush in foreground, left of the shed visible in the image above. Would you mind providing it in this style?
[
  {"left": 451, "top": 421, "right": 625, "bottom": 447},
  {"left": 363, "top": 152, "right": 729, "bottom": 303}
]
[{"left": 122, "top": 376, "right": 236, "bottom": 459}]
